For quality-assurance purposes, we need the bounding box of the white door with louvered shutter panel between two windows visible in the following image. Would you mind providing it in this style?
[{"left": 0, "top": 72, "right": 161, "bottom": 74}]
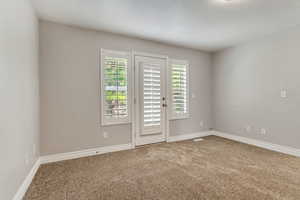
[{"left": 134, "top": 56, "right": 167, "bottom": 145}]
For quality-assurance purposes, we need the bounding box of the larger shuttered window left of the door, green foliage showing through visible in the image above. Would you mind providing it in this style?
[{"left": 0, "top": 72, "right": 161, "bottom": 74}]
[{"left": 101, "top": 49, "right": 131, "bottom": 125}]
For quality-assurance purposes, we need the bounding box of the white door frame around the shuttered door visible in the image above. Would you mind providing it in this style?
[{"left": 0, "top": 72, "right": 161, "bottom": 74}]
[{"left": 131, "top": 50, "right": 170, "bottom": 148}]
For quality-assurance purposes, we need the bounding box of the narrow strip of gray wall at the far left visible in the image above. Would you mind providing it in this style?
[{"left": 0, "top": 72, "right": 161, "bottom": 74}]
[{"left": 0, "top": 0, "right": 39, "bottom": 200}]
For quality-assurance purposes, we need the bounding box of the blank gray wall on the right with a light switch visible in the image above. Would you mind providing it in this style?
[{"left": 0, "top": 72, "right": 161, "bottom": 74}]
[{"left": 213, "top": 25, "right": 300, "bottom": 148}]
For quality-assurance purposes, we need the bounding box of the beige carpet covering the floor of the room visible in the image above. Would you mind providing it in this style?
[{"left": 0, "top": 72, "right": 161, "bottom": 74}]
[{"left": 24, "top": 136, "right": 300, "bottom": 200}]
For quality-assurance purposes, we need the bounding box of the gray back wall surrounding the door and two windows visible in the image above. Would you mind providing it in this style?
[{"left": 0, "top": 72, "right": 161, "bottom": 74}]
[{"left": 40, "top": 21, "right": 212, "bottom": 155}]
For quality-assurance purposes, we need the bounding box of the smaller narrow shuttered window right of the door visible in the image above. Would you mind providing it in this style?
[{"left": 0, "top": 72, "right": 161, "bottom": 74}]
[{"left": 169, "top": 59, "right": 189, "bottom": 119}]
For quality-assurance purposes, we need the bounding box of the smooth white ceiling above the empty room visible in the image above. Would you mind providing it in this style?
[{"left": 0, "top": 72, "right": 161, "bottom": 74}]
[{"left": 32, "top": 0, "right": 300, "bottom": 51}]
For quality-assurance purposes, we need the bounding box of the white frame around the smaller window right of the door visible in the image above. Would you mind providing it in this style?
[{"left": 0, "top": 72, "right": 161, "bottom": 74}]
[{"left": 168, "top": 58, "right": 190, "bottom": 120}]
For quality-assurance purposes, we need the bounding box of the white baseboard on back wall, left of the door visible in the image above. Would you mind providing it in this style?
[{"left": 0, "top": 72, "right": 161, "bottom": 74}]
[{"left": 40, "top": 144, "right": 132, "bottom": 164}]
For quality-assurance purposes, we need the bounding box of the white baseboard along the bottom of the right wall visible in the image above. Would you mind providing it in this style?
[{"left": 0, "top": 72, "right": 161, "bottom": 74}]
[{"left": 212, "top": 131, "right": 300, "bottom": 157}]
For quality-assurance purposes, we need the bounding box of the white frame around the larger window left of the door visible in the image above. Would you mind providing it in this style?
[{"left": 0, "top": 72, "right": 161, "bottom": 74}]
[{"left": 100, "top": 49, "right": 132, "bottom": 126}]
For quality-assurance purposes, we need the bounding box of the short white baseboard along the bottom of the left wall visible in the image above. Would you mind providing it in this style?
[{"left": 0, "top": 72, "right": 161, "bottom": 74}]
[{"left": 13, "top": 159, "right": 41, "bottom": 200}]
